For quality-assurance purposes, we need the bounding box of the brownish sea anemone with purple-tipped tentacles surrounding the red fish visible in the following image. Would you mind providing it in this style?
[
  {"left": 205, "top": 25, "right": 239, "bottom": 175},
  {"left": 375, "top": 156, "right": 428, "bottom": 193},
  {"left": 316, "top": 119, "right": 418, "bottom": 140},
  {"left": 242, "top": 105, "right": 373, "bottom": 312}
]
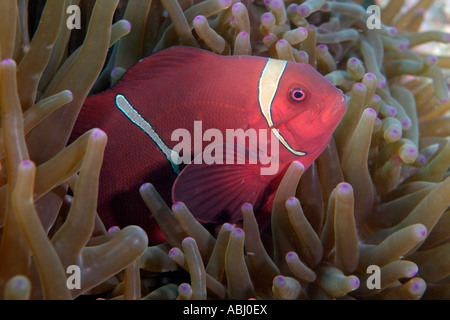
[{"left": 0, "top": 0, "right": 450, "bottom": 299}]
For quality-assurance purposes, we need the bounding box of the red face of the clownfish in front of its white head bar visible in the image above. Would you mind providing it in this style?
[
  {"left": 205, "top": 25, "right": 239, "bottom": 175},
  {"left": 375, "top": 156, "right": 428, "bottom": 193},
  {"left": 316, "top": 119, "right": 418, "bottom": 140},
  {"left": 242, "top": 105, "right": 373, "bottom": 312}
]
[{"left": 266, "top": 62, "right": 346, "bottom": 157}]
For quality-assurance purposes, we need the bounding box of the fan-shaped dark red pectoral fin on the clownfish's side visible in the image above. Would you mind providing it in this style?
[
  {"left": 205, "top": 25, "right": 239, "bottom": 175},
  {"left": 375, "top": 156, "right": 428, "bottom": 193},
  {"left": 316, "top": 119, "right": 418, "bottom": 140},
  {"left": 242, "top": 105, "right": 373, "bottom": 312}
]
[{"left": 172, "top": 147, "right": 271, "bottom": 224}]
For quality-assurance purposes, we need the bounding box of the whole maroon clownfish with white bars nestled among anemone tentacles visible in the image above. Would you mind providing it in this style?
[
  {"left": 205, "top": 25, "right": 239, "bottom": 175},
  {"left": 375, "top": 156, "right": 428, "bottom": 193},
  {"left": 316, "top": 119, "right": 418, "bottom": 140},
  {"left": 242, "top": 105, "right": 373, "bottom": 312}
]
[{"left": 71, "top": 47, "right": 346, "bottom": 244}]
